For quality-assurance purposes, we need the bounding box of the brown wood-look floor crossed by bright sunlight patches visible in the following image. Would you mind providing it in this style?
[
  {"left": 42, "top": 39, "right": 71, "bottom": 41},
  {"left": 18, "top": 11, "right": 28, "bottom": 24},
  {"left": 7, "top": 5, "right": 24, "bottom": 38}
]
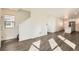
[{"left": 0, "top": 31, "right": 79, "bottom": 51}]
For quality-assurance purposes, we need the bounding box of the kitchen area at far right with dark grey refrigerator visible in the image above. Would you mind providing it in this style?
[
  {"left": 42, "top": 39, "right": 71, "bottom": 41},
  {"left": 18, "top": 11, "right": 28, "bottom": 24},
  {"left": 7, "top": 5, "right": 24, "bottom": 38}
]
[{"left": 64, "top": 11, "right": 79, "bottom": 33}]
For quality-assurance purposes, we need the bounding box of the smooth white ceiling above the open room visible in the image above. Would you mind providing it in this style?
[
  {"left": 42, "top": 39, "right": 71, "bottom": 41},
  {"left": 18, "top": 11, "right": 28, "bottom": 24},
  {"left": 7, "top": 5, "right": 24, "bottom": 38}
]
[{"left": 7, "top": 8, "right": 79, "bottom": 17}]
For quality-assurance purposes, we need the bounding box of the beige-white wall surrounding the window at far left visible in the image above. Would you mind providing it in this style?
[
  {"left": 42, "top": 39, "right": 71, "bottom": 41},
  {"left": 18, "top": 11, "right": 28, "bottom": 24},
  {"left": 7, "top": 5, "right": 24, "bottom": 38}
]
[{"left": 2, "top": 8, "right": 30, "bottom": 40}]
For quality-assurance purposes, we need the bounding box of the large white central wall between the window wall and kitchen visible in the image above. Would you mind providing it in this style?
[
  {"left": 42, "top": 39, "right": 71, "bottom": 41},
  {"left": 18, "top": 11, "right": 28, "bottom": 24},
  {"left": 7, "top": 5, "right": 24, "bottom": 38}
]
[{"left": 19, "top": 9, "right": 62, "bottom": 41}]
